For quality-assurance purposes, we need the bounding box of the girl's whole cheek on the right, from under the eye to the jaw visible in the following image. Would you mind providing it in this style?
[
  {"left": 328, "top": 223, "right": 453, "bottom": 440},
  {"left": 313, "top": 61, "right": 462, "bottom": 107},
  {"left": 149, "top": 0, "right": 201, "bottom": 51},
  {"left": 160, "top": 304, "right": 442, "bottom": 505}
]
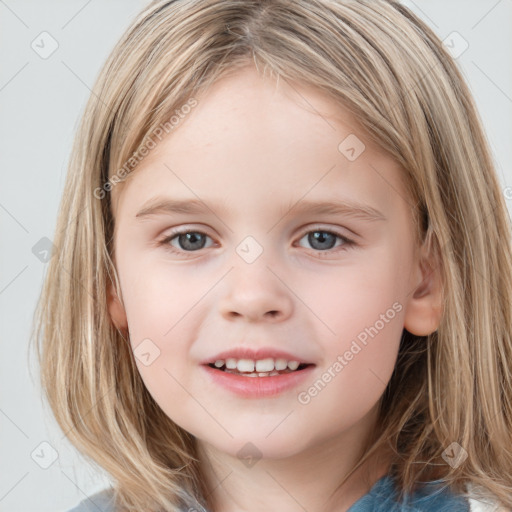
[{"left": 299, "top": 253, "right": 406, "bottom": 408}]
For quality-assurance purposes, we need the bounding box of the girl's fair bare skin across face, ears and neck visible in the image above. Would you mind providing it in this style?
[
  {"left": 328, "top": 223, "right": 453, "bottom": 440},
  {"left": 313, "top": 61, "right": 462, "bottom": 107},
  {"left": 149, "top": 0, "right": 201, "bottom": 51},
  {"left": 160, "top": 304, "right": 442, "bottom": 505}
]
[{"left": 109, "top": 67, "right": 441, "bottom": 512}]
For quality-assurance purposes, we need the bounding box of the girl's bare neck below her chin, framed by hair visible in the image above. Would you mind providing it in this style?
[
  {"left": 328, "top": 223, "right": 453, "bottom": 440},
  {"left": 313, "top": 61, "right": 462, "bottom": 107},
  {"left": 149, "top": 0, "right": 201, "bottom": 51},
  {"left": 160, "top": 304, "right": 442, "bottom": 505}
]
[{"left": 197, "top": 410, "right": 389, "bottom": 512}]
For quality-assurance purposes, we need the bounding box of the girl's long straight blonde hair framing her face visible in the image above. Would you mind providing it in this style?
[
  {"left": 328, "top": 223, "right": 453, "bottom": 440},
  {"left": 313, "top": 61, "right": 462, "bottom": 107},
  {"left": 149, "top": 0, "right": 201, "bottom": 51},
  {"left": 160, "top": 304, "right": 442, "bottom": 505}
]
[{"left": 34, "top": 0, "right": 512, "bottom": 511}]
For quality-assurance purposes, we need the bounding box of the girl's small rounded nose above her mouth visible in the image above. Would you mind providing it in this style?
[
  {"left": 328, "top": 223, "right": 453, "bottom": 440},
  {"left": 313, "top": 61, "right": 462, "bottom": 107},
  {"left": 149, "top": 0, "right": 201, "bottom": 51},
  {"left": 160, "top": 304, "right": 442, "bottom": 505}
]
[{"left": 219, "top": 261, "right": 293, "bottom": 322}]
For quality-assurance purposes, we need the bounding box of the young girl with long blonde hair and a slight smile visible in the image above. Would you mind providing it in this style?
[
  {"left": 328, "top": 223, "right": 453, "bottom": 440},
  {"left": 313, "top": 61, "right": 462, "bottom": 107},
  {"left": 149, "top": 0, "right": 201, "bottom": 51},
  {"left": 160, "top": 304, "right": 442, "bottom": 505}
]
[{"left": 32, "top": 0, "right": 512, "bottom": 512}]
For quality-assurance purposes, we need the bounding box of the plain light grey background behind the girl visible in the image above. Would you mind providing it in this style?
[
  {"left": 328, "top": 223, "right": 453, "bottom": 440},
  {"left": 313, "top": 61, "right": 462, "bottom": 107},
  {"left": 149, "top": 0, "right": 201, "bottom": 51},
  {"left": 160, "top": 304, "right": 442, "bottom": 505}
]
[{"left": 0, "top": 0, "right": 512, "bottom": 512}]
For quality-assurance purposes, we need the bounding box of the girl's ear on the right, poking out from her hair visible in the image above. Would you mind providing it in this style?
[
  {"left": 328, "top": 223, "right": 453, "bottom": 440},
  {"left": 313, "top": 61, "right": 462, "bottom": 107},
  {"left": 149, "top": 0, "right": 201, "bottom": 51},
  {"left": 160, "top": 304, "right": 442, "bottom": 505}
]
[{"left": 404, "top": 235, "right": 443, "bottom": 336}]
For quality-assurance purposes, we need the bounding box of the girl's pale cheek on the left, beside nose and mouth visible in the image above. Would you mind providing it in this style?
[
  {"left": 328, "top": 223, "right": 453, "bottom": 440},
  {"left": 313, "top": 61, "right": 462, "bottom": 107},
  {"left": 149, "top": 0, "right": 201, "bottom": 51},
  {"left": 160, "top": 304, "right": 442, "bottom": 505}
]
[{"left": 119, "top": 257, "right": 211, "bottom": 416}]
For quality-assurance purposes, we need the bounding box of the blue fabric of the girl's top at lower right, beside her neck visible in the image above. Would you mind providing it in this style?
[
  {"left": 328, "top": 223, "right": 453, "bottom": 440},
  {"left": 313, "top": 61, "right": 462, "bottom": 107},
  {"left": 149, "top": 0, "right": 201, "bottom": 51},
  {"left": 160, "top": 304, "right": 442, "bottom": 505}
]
[{"left": 348, "top": 476, "right": 471, "bottom": 512}]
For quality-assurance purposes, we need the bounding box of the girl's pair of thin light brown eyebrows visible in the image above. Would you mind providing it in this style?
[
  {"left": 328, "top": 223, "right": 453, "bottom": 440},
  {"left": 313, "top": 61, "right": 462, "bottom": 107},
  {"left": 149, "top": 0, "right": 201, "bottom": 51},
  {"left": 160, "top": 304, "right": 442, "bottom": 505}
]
[{"left": 135, "top": 197, "right": 387, "bottom": 222}]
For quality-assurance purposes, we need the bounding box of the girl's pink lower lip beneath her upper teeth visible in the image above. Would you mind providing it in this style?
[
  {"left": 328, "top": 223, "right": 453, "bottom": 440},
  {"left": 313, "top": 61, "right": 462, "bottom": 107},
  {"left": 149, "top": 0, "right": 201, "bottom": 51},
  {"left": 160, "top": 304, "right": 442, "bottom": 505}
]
[{"left": 202, "top": 365, "right": 315, "bottom": 398}]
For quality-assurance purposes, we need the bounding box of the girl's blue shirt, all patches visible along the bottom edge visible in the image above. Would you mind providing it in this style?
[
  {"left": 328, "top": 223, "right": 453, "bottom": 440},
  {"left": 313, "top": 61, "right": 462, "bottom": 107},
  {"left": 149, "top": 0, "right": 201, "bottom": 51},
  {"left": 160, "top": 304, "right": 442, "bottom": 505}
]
[{"left": 69, "top": 476, "right": 470, "bottom": 512}]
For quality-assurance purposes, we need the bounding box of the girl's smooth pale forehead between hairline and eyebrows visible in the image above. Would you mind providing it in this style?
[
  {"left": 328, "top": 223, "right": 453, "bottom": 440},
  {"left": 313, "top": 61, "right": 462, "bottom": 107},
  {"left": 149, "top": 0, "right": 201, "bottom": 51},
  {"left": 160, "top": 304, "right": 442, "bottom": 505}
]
[{"left": 112, "top": 68, "right": 408, "bottom": 228}]
